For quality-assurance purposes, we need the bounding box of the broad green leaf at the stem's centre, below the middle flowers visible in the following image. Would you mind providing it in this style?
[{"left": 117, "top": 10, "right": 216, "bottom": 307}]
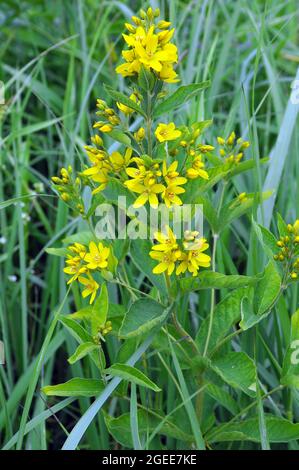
[{"left": 119, "top": 299, "right": 172, "bottom": 338}]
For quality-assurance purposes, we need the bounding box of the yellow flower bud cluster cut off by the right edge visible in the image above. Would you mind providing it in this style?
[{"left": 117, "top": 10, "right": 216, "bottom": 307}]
[{"left": 274, "top": 219, "right": 299, "bottom": 281}]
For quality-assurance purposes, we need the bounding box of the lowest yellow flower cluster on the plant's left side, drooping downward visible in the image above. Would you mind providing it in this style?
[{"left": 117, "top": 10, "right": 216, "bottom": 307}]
[{"left": 63, "top": 242, "right": 110, "bottom": 304}]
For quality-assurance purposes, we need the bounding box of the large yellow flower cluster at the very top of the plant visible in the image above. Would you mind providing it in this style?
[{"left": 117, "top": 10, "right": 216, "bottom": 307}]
[{"left": 116, "top": 8, "right": 178, "bottom": 83}]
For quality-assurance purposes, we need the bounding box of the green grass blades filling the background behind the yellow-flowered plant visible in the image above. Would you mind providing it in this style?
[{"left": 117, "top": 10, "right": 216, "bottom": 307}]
[{"left": 0, "top": 0, "right": 299, "bottom": 449}]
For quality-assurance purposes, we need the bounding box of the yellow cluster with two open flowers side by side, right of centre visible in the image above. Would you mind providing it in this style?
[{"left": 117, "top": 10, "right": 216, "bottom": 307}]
[{"left": 150, "top": 227, "right": 211, "bottom": 276}]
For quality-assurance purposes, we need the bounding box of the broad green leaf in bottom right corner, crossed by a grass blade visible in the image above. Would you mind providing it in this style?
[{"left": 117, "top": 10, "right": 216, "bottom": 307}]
[{"left": 205, "top": 414, "right": 299, "bottom": 443}]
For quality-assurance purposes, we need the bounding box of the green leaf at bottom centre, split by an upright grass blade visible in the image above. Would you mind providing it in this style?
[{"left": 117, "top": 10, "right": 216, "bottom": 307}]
[{"left": 105, "top": 410, "right": 194, "bottom": 449}]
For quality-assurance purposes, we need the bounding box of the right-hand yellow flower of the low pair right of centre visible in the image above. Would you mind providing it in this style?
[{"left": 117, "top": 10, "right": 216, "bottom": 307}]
[{"left": 176, "top": 238, "right": 211, "bottom": 276}]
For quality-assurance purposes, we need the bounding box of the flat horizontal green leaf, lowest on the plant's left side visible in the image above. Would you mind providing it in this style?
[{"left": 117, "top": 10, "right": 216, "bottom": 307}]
[{"left": 42, "top": 377, "right": 104, "bottom": 397}]
